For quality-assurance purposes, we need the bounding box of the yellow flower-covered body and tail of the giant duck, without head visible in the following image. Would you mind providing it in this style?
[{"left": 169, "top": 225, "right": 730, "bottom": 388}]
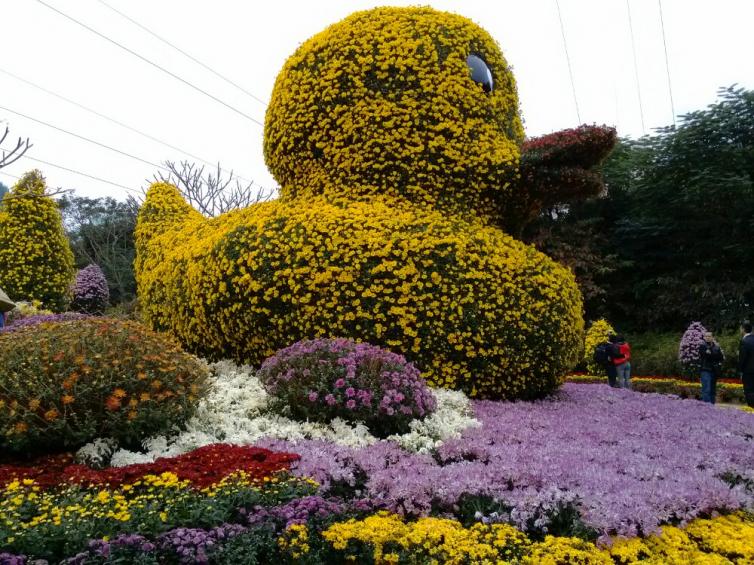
[{"left": 139, "top": 185, "right": 583, "bottom": 398}]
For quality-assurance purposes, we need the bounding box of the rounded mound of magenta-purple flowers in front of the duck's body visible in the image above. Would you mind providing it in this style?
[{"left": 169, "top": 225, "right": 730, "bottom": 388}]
[{"left": 259, "top": 339, "right": 436, "bottom": 437}]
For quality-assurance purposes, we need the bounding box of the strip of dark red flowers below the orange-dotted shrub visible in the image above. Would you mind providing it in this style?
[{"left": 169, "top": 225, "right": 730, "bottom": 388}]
[{"left": 0, "top": 443, "right": 299, "bottom": 488}]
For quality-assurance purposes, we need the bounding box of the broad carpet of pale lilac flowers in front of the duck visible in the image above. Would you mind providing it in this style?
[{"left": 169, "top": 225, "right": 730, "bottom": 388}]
[{"left": 256, "top": 383, "right": 754, "bottom": 536}]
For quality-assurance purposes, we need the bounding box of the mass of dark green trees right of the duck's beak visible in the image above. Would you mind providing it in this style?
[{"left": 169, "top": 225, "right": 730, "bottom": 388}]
[{"left": 526, "top": 87, "right": 754, "bottom": 331}]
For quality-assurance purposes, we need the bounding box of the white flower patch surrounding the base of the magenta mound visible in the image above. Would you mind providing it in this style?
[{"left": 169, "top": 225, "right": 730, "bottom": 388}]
[{"left": 78, "top": 361, "right": 481, "bottom": 467}]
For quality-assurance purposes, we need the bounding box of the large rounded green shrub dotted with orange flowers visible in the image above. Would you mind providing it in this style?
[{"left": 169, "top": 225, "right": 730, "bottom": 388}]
[{"left": 0, "top": 318, "right": 208, "bottom": 451}]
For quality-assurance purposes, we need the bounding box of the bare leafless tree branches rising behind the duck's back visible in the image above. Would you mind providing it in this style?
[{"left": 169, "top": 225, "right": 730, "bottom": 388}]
[{"left": 154, "top": 161, "right": 273, "bottom": 217}]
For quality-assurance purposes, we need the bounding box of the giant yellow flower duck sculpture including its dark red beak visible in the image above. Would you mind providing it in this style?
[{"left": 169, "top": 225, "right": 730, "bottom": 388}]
[{"left": 136, "top": 8, "right": 614, "bottom": 399}]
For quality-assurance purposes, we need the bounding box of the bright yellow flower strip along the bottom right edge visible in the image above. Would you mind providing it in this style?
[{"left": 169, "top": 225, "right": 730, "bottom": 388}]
[{"left": 310, "top": 512, "right": 754, "bottom": 565}]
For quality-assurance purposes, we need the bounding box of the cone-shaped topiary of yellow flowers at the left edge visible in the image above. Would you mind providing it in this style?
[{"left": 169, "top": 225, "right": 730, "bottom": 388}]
[{"left": 0, "top": 171, "right": 74, "bottom": 311}]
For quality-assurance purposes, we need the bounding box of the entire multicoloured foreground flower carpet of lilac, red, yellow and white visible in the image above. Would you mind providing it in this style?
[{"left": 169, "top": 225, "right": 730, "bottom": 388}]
[{"left": 0, "top": 376, "right": 754, "bottom": 563}]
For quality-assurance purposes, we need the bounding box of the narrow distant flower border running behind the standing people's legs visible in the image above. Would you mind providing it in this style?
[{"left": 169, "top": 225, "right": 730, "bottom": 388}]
[{"left": 567, "top": 374, "right": 746, "bottom": 404}]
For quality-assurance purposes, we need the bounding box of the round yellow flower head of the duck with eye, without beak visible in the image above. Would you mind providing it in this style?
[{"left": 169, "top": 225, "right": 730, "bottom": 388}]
[{"left": 264, "top": 8, "right": 523, "bottom": 218}]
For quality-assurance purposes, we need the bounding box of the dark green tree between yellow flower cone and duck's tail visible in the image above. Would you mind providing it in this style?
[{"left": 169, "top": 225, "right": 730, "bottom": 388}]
[{"left": 59, "top": 196, "right": 139, "bottom": 304}]
